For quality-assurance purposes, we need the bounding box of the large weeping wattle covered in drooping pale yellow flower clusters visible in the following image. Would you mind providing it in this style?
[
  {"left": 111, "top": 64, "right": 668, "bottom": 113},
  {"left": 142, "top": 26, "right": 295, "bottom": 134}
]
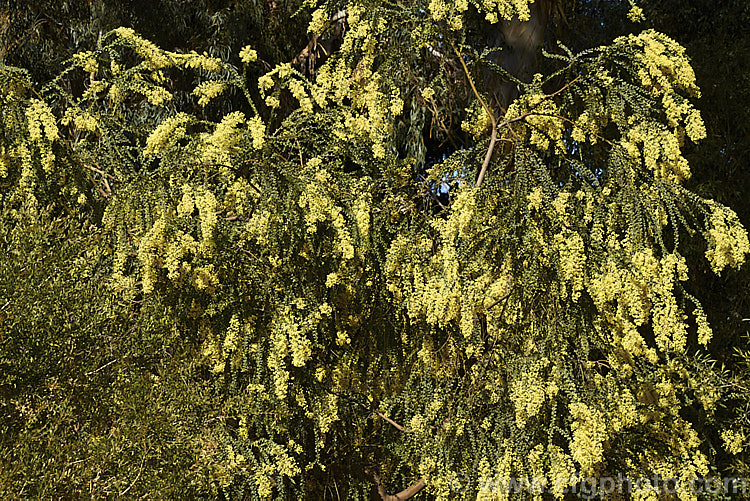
[{"left": 0, "top": 0, "right": 750, "bottom": 499}]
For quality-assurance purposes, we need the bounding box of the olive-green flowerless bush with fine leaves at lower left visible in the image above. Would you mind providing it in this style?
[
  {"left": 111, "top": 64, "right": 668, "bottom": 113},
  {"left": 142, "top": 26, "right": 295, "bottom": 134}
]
[{"left": 0, "top": 215, "right": 218, "bottom": 499}]
